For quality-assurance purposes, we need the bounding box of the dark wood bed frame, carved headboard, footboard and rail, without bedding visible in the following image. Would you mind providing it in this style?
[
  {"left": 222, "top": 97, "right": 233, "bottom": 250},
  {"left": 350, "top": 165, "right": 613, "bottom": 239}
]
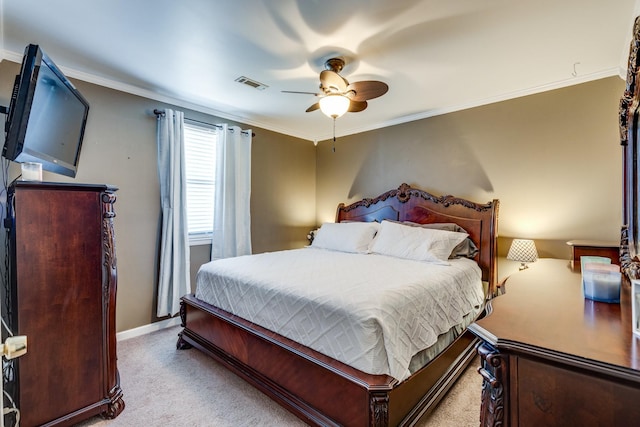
[{"left": 178, "top": 184, "right": 498, "bottom": 426}]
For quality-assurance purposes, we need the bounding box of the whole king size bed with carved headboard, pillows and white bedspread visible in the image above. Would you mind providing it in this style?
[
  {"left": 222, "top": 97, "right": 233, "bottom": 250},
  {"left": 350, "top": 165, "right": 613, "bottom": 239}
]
[{"left": 178, "top": 184, "right": 498, "bottom": 426}]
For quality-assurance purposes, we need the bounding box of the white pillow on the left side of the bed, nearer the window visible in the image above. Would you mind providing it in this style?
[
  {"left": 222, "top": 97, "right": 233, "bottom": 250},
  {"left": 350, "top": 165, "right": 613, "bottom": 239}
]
[{"left": 311, "top": 222, "right": 380, "bottom": 254}]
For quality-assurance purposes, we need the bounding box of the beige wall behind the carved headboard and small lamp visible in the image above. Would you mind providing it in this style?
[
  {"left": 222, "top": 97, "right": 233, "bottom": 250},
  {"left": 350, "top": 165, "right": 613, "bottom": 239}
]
[{"left": 316, "top": 77, "right": 624, "bottom": 258}]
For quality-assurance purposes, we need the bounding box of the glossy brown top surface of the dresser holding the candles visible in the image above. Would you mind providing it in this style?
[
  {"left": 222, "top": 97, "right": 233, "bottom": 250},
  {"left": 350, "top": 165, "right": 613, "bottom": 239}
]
[{"left": 470, "top": 258, "right": 640, "bottom": 370}]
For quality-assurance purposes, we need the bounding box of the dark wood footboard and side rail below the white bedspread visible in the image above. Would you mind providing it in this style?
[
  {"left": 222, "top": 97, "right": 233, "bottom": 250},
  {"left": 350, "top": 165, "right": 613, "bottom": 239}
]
[{"left": 178, "top": 295, "right": 477, "bottom": 427}]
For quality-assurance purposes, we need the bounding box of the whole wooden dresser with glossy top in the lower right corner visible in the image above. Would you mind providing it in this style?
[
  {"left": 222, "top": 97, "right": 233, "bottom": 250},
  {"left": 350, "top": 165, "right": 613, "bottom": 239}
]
[{"left": 469, "top": 259, "right": 640, "bottom": 426}]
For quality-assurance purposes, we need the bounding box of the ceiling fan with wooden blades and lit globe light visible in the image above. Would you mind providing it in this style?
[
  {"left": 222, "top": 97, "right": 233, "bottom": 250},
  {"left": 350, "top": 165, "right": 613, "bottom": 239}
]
[{"left": 282, "top": 58, "right": 389, "bottom": 119}]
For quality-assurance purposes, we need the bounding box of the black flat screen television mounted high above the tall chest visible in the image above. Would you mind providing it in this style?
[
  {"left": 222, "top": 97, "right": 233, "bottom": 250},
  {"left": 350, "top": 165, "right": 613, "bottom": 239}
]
[{"left": 2, "top": 44, "right": 89, "bottom": 177}]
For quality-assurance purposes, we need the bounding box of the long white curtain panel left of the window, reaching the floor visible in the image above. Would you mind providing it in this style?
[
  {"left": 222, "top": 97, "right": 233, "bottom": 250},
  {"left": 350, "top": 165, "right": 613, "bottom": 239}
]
[{"left": 157, "top": 109, "right": 191, "bottom": 317}]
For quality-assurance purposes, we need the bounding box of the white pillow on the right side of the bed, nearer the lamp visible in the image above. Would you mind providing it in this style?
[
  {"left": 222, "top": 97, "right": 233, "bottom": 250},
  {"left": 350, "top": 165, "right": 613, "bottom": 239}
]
[{"left": 370, "top": 221, "right": 469, "bottom": 265}]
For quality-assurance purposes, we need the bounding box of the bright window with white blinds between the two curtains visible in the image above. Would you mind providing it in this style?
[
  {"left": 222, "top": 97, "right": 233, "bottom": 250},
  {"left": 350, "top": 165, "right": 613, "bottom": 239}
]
[{"left": 184, "top": 120, "right": 218, "bottom": 245}]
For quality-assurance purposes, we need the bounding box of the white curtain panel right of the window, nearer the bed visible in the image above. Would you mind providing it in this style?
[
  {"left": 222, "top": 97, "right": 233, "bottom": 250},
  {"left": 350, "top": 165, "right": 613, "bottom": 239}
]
[{"left": 211, "top": 125, "right": 252, "bottom": 260}]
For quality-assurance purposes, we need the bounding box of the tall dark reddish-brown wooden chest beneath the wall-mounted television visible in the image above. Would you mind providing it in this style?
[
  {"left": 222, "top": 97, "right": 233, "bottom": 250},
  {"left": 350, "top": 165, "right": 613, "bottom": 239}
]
[{"left": 3, "top": 181, "right": 124, "bottom": 427}]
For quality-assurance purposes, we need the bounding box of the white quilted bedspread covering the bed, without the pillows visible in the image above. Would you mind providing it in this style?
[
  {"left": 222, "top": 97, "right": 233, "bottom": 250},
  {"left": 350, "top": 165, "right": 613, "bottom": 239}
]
[{"left": 196, "top": 247, "right": 483, "bottom": 381}]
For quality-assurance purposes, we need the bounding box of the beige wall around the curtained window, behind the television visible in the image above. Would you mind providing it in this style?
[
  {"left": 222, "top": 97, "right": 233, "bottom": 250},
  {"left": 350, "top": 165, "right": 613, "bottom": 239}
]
[{"left": 0, "top": 61, "right": 315, "bottom": 331}]
